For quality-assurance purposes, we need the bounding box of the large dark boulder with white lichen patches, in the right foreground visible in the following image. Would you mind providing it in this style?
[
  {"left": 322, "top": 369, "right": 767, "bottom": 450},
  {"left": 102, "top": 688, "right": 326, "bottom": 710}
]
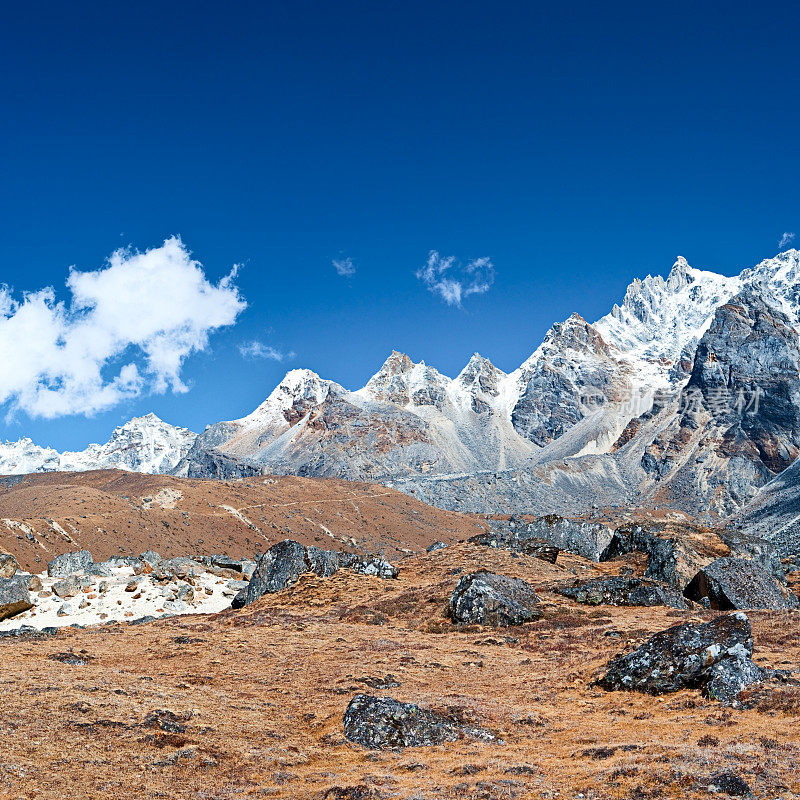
[{"left": 597, "top": 612, "right": 769, "bottom": 705}]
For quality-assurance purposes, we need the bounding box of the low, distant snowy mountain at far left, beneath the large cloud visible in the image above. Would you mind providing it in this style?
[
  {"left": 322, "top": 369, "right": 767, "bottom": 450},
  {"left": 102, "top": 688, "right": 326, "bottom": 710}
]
[{"left": 0, "top": 414, "right": 197, "bottom": 475}]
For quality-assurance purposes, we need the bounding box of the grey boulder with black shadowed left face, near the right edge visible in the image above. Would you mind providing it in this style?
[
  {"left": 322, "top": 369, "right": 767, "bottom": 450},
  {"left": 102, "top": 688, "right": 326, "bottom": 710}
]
[{"left": 684, "top": 558, "right": 799, "bottom": 611}]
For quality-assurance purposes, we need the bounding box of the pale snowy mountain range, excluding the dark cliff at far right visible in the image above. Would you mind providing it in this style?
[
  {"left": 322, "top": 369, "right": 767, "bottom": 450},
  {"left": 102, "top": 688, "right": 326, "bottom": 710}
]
[{"left": 9, "top": 250, "right": 800, "bottom": 524}]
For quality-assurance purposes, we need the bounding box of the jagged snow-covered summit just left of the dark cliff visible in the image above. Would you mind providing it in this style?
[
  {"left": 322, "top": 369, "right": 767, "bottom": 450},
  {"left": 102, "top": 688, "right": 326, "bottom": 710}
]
[{"left": 594, "top": 257, "right": 742, "bottom": 364}]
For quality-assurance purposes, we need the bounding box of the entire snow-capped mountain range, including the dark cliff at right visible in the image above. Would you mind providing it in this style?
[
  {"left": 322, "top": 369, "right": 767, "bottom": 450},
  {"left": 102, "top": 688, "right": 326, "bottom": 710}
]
[{"left": 0, "top": 250, "right": 800, "bottom": 536}]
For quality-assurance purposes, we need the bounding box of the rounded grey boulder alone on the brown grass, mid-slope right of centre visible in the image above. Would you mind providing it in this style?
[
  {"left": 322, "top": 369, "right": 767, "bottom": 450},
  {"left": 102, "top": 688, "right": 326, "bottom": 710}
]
[{"left": 449, "top": 572, "right": 542, "bottom": 626}]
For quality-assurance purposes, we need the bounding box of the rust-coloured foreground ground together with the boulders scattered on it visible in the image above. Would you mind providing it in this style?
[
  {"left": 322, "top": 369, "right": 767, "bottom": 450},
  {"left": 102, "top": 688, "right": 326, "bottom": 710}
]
[{"left": 0, "top": 510, "right": 800, "bottom": 800}]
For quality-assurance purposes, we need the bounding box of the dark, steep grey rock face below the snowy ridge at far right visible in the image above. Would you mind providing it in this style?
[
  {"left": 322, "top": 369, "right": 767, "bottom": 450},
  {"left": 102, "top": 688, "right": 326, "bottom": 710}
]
[{"left": 642, "top": 287, "right": 800, "bottom": 515}]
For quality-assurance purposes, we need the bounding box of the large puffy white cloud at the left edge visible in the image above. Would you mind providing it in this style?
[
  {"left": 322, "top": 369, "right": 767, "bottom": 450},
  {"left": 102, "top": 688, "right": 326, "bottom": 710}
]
[{"left": 0, "top": 238, "right": 246, "bottom": 419}]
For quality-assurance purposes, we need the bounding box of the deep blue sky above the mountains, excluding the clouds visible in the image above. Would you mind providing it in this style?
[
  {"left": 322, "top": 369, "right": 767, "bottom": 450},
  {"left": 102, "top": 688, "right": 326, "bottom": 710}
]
[{"left": 0, "top": 2, "right": 800, "bottom": 448}]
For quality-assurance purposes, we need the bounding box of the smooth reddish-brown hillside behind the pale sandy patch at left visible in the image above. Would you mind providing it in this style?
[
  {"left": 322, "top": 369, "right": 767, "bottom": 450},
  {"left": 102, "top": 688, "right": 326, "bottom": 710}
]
[{"left": 0, "top": 470, "right": 482, "bottom": 572}]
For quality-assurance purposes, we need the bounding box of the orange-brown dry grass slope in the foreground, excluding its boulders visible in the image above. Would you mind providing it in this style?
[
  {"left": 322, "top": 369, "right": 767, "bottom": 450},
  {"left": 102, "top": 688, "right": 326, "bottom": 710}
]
[{"left": 0, "top": 544, "right": 800, "bottom": 800}]
